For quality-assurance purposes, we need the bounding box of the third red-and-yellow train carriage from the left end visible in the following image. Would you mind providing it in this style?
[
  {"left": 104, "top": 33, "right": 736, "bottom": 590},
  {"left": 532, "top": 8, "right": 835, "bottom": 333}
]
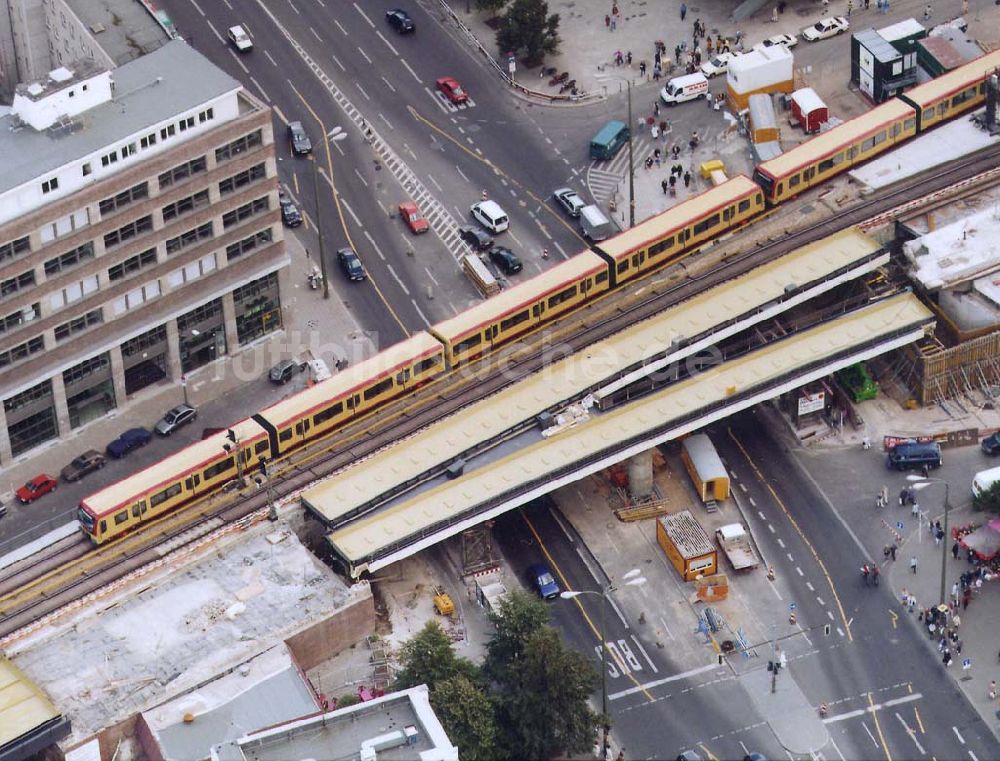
[{"left": 430, "top": 250, "right": 609, "bottom": 367}]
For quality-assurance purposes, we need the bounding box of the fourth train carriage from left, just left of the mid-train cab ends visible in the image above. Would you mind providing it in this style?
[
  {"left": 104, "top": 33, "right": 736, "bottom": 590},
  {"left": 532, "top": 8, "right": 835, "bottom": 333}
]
[{"left": 594, "top": 175, "right": 764, "bottom": 288}]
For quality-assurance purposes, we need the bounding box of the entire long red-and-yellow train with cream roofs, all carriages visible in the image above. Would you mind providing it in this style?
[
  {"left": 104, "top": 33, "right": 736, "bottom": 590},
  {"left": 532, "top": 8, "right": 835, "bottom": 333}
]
[{"left": 78, "top": 51, "right": 1000, "bottom": 544}]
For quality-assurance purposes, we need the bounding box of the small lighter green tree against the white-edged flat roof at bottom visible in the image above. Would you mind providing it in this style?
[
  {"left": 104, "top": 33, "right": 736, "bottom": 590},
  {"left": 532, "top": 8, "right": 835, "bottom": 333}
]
[{"left": 431, "top": 676, "right": 500, "bottom": 761}]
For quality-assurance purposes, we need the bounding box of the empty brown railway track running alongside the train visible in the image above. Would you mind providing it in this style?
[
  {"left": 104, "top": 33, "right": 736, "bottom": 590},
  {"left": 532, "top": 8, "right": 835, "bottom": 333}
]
[{"left": 0, "top": 146, "right": 1000, "bottom": 647}]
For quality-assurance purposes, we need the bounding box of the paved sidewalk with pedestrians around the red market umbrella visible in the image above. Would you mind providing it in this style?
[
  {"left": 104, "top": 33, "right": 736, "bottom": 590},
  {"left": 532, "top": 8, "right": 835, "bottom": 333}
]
[{"left": 881, "top": 498, "right": 1000, "bottom": 733}]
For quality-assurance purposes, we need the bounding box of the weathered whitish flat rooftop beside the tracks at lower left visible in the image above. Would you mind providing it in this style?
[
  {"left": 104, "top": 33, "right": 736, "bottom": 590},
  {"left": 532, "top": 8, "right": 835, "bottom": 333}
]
[{"left": 7, "top": 523, "right": 362, "bottom": 744}]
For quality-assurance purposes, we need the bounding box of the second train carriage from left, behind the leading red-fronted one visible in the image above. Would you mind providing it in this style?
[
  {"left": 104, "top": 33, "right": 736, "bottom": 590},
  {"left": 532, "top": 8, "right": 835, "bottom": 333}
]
[{"left": 253, "top": 332, "right": 445, "bottom": 455}]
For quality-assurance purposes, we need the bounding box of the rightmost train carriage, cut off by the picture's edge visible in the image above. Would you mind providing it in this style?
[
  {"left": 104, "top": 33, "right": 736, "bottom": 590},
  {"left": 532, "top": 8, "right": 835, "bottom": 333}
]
[{"left": 899, "top": 50, "right": 1000, "bottom": 132}]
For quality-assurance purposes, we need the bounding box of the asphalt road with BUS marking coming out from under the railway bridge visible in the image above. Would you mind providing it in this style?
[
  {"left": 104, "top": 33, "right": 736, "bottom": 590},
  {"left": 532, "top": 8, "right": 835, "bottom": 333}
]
[{"left": 495, "top": 412, "right": 1000, "bottom": 760}]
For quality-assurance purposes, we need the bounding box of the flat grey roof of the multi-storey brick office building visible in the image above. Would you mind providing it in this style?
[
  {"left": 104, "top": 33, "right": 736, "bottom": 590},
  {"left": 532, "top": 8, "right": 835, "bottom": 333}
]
[{"left": 0, "top": 38, "right": 241, "bottom": 194}]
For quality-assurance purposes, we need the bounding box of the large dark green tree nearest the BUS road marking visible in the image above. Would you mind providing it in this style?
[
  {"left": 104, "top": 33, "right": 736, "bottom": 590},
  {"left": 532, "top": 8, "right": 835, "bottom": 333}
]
[{"left": 497, "top": 626, "right": 600, "bottom": 759}]
